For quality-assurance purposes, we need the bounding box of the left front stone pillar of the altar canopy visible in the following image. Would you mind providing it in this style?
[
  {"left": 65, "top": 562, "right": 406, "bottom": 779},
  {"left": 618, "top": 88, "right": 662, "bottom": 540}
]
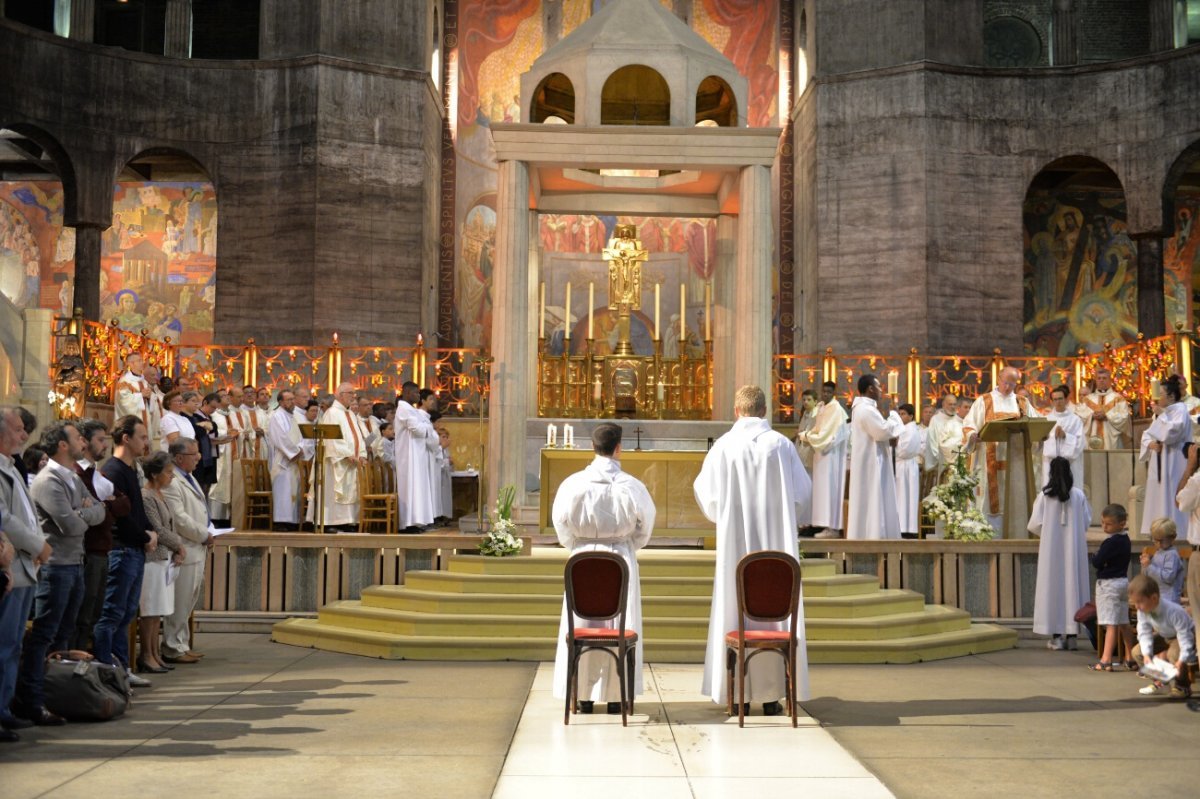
[{"left": 485, "top": 161, "right": 532, "bottom": 507}]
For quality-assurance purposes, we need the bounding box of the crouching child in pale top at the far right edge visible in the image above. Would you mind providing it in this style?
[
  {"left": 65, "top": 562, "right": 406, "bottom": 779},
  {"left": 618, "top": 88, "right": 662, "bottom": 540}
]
[{"left": 1129, "top": 575, "right": 1196, "bottom": 698}]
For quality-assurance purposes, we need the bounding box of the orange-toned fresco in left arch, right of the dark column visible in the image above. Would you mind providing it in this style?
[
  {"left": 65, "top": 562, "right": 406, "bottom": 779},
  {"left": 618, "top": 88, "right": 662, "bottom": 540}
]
[{"left": 100, "top": 182, "right": 217, "bottom": 346}]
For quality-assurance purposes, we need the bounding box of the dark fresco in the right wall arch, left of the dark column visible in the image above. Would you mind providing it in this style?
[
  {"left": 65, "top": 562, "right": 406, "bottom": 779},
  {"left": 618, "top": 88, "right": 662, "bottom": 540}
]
[{"left": 1024, "top": 192, "right": 1138, "bottom": 355}]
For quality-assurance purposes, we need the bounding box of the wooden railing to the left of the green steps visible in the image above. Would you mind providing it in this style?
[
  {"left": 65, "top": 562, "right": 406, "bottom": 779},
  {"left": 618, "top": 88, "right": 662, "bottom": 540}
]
[{"left": 200, "top": 533, "right": 530, "bottom": 614}]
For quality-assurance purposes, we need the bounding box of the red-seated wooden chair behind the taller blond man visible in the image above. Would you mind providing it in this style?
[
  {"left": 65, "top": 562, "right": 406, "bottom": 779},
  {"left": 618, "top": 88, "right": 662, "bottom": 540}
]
[{"left": 725, "top": 549, "right": 800, "bottom": 727}]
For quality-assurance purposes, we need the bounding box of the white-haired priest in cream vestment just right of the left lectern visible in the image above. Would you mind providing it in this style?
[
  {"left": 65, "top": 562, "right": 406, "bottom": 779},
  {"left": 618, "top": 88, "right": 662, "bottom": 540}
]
[{"left": 304, "top": 383, "right": 367, "bottom": 530}]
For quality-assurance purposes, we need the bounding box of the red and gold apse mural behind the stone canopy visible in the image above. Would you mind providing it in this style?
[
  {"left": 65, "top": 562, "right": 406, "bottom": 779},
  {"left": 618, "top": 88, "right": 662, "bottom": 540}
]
[{"left": 455, "top": 0, "right": 779, "bottom": 347}]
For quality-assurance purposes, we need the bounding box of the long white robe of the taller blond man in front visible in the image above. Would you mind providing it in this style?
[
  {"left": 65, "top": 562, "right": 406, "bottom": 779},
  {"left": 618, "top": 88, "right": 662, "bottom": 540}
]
[{"left": 692, "top": 416, "right": 812, "bottom": 704}]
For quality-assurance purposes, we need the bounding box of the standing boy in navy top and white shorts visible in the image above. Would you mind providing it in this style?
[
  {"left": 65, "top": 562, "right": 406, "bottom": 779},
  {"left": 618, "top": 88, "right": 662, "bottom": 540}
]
[{"left": 1088, "top": 505, "right": 1138, "bottom": 672}]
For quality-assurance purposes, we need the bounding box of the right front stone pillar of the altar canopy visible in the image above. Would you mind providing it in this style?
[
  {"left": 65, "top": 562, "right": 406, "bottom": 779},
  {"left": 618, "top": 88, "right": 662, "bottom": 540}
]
[{"left": 734, "top": 166, "right": 774, "bottom": 417}]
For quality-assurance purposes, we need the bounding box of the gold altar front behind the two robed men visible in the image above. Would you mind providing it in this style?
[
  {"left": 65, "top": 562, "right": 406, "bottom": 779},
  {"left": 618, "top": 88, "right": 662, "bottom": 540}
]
[{"left": 538, "top": 447, "right": 714, "bottom": 541}]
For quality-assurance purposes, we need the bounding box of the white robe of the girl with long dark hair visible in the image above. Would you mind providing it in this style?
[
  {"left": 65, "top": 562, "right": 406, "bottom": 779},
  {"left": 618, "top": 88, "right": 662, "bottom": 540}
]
[{"left": 1028, "top": 486, "right": 1092, "bottom": 636}]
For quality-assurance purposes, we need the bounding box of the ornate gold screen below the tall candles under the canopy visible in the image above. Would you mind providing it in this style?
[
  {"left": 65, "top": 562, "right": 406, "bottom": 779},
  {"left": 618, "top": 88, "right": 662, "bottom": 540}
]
[{"left": 538, "top": 338, "right": 713, "bottom": 420}]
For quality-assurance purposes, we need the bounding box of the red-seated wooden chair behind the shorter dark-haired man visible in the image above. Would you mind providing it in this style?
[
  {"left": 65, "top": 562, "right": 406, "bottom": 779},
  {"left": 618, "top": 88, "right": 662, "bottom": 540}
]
[{"left": 563, "top": 552, "right": 637, "bottom": 727}]
